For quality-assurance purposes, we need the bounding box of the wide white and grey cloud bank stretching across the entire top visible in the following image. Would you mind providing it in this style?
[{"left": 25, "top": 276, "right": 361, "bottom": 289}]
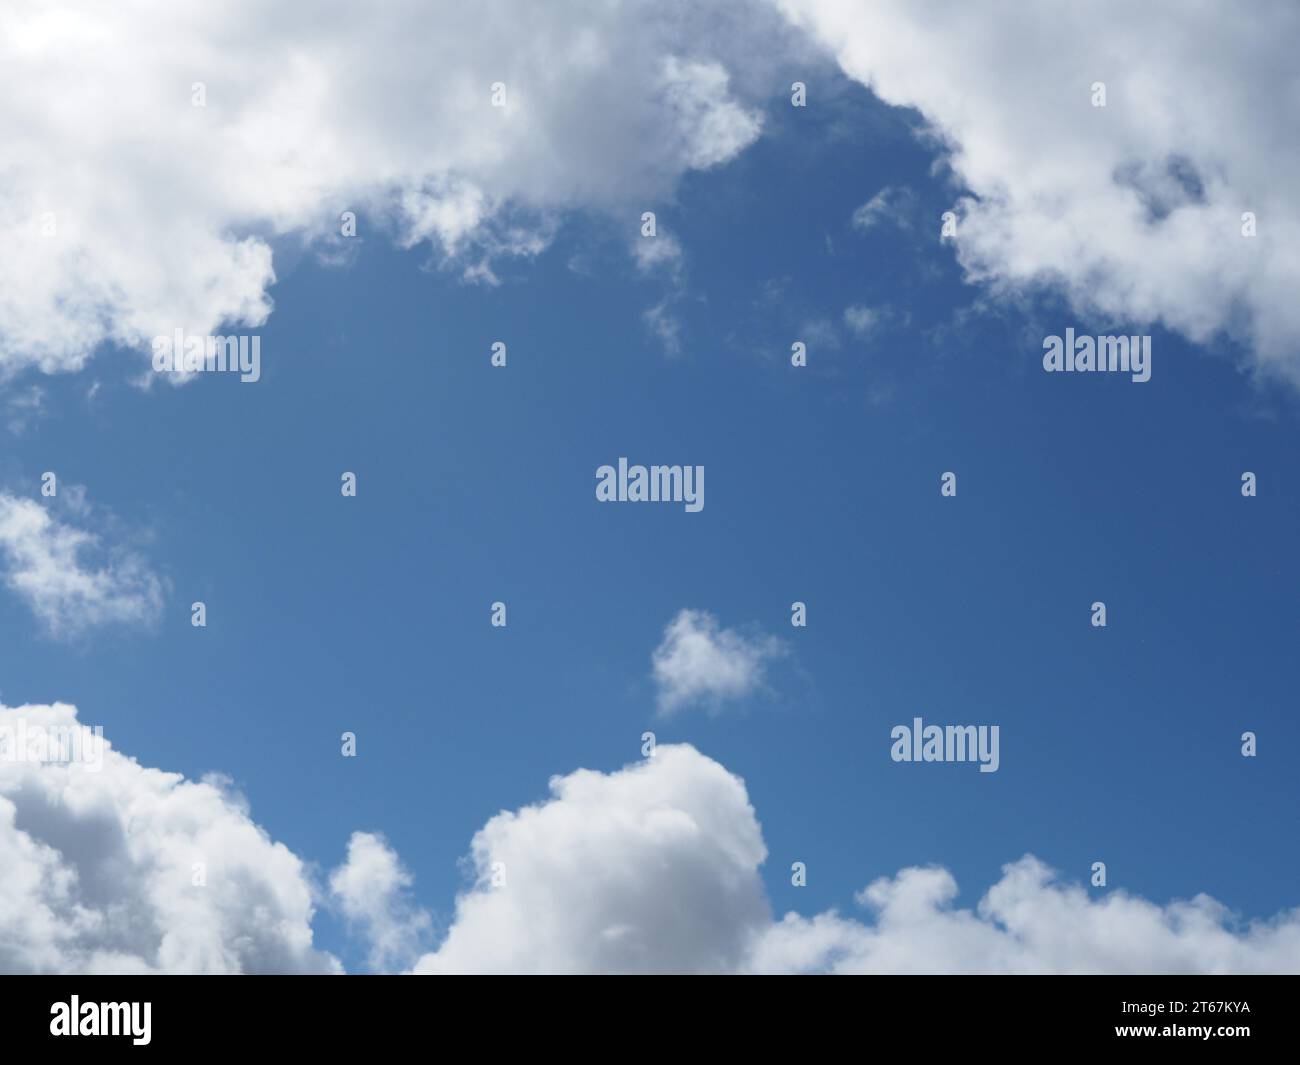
[{"left": 10, "top": 0, "right": 1300, "bottom": 381}]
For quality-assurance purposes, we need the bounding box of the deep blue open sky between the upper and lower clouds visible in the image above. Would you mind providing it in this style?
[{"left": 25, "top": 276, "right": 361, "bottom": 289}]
[{"left": 0, "top": 0, "right": 1300, "bottom": 969}]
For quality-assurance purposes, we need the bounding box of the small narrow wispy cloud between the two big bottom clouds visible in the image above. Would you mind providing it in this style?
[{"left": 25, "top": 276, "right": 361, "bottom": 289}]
[{"left": 329, "top": 832, "right": 432, "bottom": 970}]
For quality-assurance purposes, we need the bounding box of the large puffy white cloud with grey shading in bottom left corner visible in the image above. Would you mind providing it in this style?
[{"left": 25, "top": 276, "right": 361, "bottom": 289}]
[{"left": 0, "top": 703, "right": 339, "bottom": 973}]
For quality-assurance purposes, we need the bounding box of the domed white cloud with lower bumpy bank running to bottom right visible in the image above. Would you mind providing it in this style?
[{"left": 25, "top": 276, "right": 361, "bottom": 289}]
[{"left": 416, "top": 745, "right": 1300, "bottom": 973}]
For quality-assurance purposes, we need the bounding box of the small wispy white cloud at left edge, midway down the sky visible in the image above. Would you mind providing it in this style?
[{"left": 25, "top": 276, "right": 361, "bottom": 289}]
[{"left": 0, "top": 486, "right": 163, "bottom": 636}]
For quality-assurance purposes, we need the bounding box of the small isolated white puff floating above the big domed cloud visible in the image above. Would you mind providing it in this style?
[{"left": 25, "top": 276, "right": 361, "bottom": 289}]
[{"left": 651, "top": 610, "right": 784, "bottom": 714}]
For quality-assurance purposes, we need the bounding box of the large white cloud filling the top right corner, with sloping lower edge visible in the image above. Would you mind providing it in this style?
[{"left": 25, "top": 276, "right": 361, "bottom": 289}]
[{"left": 779, "top": 0, "right": 1300, "bottom": 382}]
